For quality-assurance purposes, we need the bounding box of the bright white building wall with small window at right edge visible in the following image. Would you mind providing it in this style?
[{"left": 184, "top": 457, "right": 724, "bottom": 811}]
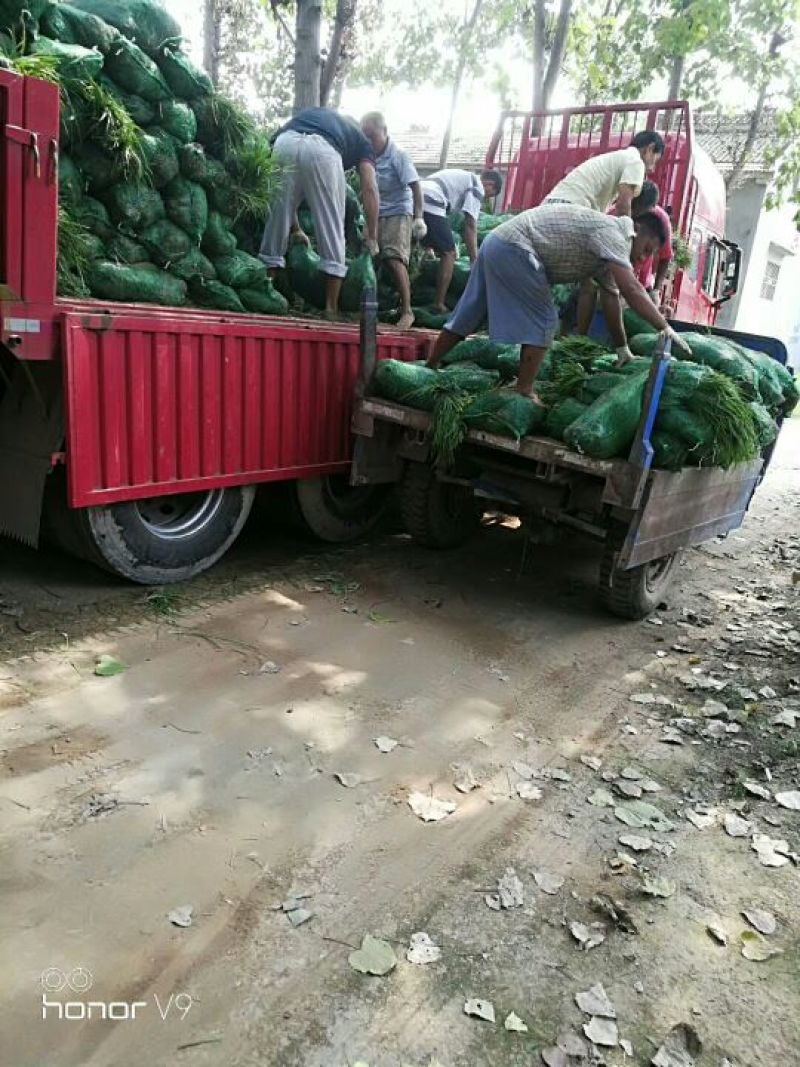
[{"left": 732, "top": 193, "right": 800, "bottom": 368}]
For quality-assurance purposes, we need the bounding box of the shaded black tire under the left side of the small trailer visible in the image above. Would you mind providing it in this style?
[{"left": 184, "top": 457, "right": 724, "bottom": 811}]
[{"left": 400, "top": 463, "right": 480, "bottom": 548}]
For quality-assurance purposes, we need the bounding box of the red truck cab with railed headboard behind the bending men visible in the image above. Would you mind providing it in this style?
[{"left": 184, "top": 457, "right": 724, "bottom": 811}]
[{"left": 486, "top": 100, "right": 741, "bottom": 325}]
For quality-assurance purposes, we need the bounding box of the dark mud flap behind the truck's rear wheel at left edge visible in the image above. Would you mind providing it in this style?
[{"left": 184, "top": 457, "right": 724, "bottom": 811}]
[{"left": 0, "top": 360, "right": 64, "bottom": 548}]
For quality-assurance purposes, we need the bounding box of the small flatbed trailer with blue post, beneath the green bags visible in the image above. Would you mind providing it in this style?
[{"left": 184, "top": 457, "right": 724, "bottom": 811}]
[{"left": 352, "top": 328, "right": 785, "bottom": 619}]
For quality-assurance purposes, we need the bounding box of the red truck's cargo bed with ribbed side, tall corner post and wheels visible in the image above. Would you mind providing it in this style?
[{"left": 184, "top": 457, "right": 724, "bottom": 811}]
[{"left": 0, "top": 70, "right": 430, "bottom": 584}]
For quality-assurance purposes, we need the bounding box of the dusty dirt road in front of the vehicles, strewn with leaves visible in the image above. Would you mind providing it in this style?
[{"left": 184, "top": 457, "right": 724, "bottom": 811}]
[{"left": 0, "top": 420, "right": 800, "bottom": 1067}]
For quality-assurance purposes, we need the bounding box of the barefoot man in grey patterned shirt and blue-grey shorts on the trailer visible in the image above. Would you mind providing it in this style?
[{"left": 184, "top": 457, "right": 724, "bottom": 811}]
[{"left": 428, "top": 204, "right": 688, "bottom": 402}]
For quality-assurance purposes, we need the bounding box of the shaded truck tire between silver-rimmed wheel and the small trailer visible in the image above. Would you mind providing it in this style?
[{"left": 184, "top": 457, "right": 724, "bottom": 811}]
[{"left": 290, "top": 475, "right": 389, "bottom": 544}]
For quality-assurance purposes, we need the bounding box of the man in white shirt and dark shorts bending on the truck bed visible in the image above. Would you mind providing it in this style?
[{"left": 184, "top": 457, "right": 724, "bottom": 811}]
[{"left": 422, "top": 168, "right": 502, "bottom": 315}]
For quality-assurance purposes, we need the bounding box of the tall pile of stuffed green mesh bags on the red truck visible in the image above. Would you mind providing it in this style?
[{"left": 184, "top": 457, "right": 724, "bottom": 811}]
[{"left": 0, "top": 0, "right": 288, "bottom": 315}]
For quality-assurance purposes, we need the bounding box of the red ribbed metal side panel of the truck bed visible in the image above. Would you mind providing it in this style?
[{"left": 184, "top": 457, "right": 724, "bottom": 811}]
[{"left": 63, "top": 312, "right": 430, "bottom": 507}]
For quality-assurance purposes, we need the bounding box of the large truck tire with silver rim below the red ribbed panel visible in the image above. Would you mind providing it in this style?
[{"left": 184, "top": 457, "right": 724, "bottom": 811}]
[{"left": 48, "top": 485, "right": 255, "bottom": 586}]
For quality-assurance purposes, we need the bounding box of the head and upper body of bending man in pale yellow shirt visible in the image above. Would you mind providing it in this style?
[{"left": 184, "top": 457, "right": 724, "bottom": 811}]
[{"left": 545, "top": 130, "right": 665, "bottom": 216}]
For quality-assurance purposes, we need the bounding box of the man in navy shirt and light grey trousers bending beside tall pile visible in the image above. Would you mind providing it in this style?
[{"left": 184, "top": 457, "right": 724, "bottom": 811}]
[{"left": 259, "top": 108, "right": 379, "bottom": 318}]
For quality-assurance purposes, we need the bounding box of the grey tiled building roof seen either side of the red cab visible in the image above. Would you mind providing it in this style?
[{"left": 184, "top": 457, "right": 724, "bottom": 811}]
[{"left": 391, "top": 111, "right": 775, "bottom": 178}]
